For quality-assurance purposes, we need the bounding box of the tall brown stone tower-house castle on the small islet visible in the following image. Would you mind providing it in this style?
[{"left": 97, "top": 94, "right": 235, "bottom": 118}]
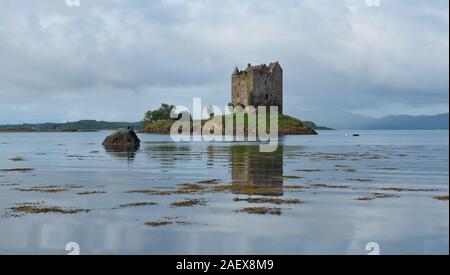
[{"left": 231, "top": 62, "right": 283, "bottom": 113}]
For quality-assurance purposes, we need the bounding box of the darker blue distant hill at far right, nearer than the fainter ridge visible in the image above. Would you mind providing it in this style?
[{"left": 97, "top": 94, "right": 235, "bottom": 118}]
[{"left": 361, "top": 113, "right": 449, "bottom": 130}]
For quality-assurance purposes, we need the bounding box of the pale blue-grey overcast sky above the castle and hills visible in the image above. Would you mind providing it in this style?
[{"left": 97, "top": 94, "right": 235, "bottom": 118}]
[{"left": 0, "top": 0, "right": 449, "bottom": 124}]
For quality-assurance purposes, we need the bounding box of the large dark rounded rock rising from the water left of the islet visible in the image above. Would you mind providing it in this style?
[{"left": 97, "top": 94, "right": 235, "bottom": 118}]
[{"left": 102, "top": 130, "right": 141, "bottom": 151}]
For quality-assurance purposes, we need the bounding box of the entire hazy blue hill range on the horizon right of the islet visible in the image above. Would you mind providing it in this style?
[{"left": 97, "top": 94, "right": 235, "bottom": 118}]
[{"left": 299, "top": 110, "right": 449, "bottom": 130}]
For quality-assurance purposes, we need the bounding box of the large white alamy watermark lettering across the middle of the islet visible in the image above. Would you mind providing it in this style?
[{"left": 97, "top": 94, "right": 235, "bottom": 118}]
[{"left": 170, "top": 98, "right": 279, "bottom": 152}]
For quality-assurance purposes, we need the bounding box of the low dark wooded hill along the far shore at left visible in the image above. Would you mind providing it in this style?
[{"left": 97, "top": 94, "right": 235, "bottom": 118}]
[{"left": 0, "top": 120, "right": 141, "bottom": 131}]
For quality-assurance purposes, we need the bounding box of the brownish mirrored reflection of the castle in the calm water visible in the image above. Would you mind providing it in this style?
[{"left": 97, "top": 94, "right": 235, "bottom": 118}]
[{"left": 230, "top": 145, "right": 283, "bottom": 196}]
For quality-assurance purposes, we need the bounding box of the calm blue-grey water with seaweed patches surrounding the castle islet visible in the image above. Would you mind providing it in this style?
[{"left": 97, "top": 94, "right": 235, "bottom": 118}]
[{"left": 0, "top": 131, "right": 449, "bottom": 254}]
